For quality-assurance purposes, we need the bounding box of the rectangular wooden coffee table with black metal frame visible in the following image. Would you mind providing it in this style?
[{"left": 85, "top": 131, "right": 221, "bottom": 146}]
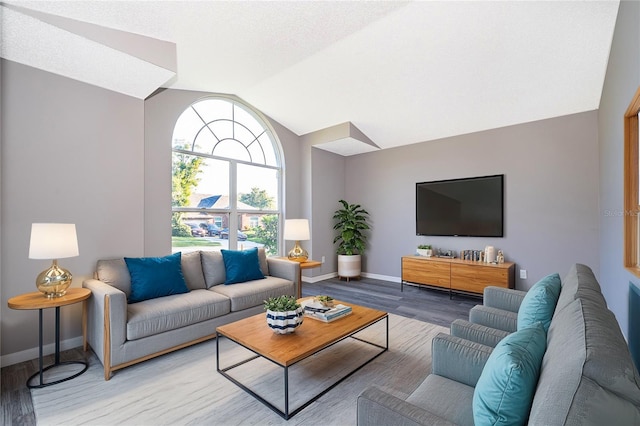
[{"left": 216, "top": 301, "right": 389, "bottom": 420}]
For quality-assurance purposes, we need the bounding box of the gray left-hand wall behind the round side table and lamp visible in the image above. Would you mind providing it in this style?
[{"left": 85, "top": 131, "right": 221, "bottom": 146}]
[{"left": 0, "top": 60, "right": 144, "bottom": 364}]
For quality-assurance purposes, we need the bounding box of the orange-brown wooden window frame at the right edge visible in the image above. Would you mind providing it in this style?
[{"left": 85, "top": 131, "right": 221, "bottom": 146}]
[{"left": 622, "top": 87, "right": 640, "bottom": 278}]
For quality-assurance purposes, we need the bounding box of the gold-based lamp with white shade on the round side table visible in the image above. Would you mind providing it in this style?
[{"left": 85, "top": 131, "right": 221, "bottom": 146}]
[{"left": 29, "top": 223, "right": 80, "bottom": 299}]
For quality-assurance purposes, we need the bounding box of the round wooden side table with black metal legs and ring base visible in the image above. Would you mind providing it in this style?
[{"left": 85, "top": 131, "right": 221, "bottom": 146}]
[{"left": 7, "top": 288, "right": 91, "bottom": 389}]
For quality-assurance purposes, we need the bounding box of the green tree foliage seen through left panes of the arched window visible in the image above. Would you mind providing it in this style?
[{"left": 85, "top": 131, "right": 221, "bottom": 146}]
[{"left": 171, "top": 152, "right": 202, "bottom": 237}]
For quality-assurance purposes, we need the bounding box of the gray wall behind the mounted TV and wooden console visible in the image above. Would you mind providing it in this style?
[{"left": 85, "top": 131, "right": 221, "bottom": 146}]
[{"left": 330, "top": 112, "right": 599, "bottom": 289}]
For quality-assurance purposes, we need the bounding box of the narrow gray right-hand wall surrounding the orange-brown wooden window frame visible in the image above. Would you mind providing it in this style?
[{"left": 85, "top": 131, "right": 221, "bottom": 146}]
[{"left": 598, "top": 1, "right": 640, "bottom": 343}]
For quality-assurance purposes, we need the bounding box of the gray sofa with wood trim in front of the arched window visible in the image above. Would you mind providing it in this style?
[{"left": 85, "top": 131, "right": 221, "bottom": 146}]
[{"left": 83, "top": 249, "right": 300, "bottom": 380}]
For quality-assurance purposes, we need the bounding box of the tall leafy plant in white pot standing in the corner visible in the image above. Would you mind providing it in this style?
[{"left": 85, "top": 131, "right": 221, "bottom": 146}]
[{"left": 333, "top": 200, "right": 371, "bottom": 281}]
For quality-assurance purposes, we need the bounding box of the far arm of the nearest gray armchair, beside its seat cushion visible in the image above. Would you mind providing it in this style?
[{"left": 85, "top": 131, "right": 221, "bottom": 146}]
[{"left": 431, "top": 333, "right": 493, "bottom": 387}]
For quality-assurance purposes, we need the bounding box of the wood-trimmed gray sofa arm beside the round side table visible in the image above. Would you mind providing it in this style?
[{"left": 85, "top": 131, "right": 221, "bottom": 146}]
[{"left": 82, "top": 279, "right": 127, "bottom": 380}]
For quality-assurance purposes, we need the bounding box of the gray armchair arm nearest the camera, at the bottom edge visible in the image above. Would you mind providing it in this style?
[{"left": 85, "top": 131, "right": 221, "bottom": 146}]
[{"left": 357, "top": 386, "right": 453, "bottom": 426}]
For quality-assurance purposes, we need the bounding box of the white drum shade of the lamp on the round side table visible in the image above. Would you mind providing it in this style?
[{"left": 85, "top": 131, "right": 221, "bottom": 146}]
[{"left": 29, "top": 223, "right": 80, "bottom": 259}]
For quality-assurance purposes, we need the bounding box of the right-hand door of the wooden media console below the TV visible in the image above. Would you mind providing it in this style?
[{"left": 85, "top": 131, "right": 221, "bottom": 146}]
[{"left": 451, "top": 264, "right": 509, "bottom": 294}]
